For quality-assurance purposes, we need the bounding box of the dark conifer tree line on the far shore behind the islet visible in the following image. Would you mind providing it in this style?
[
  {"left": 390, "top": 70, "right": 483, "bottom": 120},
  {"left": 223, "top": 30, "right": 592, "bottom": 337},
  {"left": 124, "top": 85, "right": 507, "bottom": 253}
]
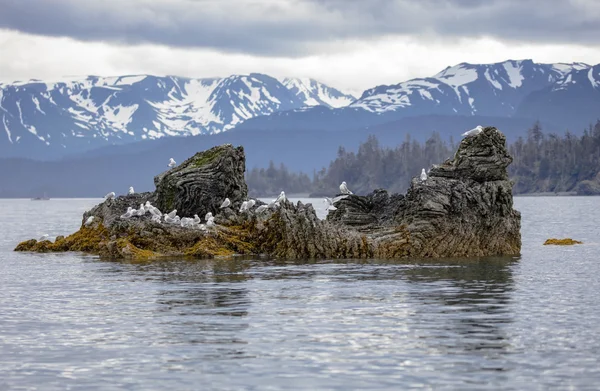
[{"left": 246, "top": 121, "right": 600, "bottom": 197}]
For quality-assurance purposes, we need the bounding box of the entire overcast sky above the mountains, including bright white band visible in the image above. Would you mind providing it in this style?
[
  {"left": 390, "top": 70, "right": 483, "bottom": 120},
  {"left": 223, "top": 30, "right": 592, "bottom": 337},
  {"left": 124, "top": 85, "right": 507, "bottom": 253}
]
[{"left": 0, "top": 0, "right": 600, "bottom": 91}]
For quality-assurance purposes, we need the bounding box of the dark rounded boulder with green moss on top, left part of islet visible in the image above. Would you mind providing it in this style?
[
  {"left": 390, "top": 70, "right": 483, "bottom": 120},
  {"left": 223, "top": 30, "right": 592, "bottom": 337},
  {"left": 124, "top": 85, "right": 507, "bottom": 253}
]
[{"left": 154, "top": 144, "right": 248, "bottom": 216}]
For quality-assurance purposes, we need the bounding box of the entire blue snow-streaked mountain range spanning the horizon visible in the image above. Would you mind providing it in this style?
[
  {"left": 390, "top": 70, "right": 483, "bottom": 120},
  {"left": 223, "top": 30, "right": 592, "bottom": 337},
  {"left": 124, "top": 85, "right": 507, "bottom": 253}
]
[{"left": 0, "top": 60, "right": 600, "bottom": 159}]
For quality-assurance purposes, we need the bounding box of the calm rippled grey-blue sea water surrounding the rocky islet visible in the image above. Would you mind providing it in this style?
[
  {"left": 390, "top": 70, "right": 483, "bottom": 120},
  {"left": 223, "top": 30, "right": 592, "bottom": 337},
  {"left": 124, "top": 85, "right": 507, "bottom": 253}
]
[{"left": 0, "top": 197, "right": 600, "bottom": 390}]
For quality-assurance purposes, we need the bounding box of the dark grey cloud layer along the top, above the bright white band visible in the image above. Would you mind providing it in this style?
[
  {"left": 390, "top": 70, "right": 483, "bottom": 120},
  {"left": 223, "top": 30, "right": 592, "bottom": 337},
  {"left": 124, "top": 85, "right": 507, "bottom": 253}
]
[{"left": 0, "top": 0, "right": 600, "bottom": 56}]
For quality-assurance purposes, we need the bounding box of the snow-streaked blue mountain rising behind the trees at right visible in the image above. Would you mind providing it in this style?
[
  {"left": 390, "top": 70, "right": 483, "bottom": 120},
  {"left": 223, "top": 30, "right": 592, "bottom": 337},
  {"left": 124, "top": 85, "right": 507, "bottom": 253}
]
[{"left": 350, "top": 60, "right": 590, "bottom": 116}]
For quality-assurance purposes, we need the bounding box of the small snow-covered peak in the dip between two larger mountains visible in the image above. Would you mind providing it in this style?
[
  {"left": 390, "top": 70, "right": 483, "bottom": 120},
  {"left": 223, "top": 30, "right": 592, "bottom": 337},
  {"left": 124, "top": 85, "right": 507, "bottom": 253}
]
[{"left": 280, "top": 77, "right": 357, "bottom": 108}]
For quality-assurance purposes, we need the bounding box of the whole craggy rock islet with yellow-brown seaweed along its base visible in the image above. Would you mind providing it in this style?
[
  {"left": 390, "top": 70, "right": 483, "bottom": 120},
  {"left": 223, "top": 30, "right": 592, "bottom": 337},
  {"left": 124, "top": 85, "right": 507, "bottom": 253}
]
[{"left": 16, "top": 127, "right": 521, "bottom": 259}]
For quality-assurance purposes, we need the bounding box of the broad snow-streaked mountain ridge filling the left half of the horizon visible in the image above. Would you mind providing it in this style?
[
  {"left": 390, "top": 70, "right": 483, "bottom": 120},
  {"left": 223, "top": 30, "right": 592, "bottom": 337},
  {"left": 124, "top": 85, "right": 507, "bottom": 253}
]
[{"left": 0, "top": 73, "right": 351, "bottom": 155}]
